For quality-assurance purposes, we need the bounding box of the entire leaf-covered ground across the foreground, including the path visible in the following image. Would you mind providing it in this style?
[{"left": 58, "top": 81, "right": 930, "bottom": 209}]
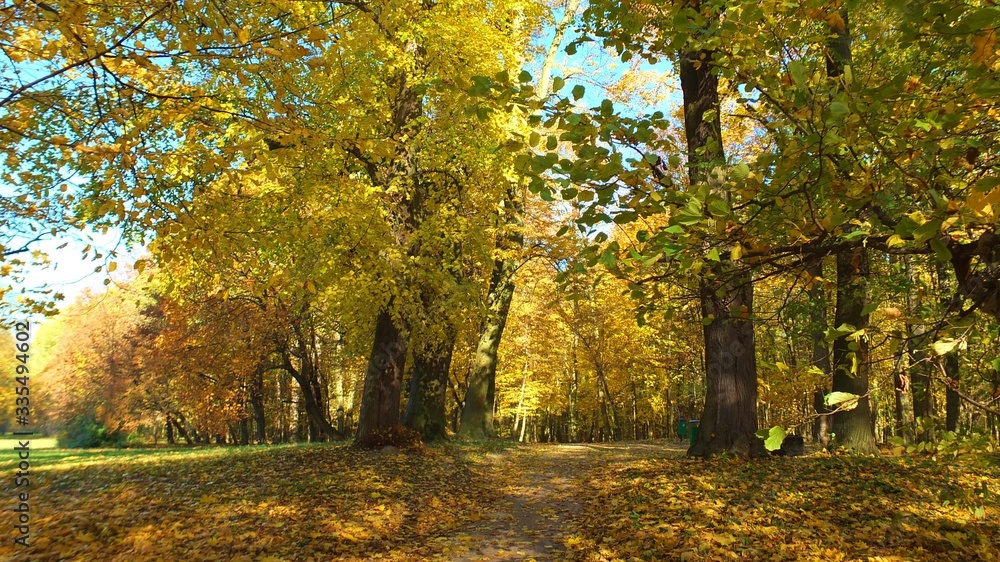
[{"left": 0, "top": 442, "right": 1000, "bottom": 562}]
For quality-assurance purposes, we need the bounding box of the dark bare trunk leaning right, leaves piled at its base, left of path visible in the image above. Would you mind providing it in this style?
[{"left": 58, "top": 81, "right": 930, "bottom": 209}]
[{"left": 355, "top": 301, "right": 406, "bottom": 446}]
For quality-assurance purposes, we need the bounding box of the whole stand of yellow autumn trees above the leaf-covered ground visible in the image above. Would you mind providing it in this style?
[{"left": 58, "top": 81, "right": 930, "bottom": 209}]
[{"left": 0, "top": 0, "right": 1000, "bottom": 456}]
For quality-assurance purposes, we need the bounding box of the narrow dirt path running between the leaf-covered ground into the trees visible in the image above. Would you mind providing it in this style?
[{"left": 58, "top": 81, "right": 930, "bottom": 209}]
[{"left": 440, "top": 443, "right": 684, "bottom": 562}]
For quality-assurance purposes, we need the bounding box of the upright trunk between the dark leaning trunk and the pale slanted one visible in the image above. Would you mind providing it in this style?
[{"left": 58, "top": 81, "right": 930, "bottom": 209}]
[{"left": 403, "top": 326, "right": 457, "bottom": 441}]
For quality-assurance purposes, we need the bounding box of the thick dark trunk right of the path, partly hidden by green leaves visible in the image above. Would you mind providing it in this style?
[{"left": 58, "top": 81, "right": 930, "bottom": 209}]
[{"left": 680, "top": 12, "right": 764, "bottom": 457}]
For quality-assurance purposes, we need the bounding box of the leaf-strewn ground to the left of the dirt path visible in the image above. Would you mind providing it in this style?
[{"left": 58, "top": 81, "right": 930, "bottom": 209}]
[{"left": 0, "top": 445, "right": 508, "bottom": 562}]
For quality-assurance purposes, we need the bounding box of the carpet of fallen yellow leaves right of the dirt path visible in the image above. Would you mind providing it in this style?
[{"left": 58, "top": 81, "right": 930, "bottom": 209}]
[{"left": 566, "top": 453, "right": 1000, "bottom": 561}]
